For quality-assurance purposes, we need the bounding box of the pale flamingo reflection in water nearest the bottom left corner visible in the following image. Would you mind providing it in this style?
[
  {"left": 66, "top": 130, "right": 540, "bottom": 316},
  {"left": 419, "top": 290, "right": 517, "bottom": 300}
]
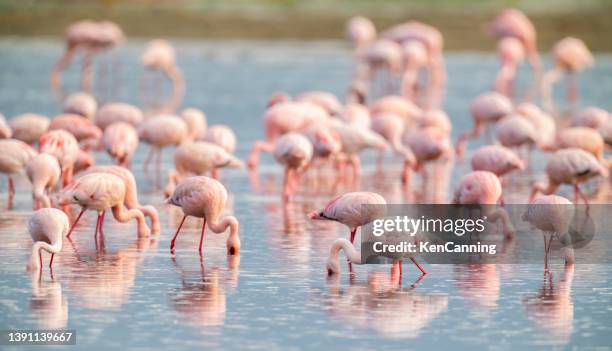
[{"left": 30, "top": 272, "right": 68, "bottom": 329}]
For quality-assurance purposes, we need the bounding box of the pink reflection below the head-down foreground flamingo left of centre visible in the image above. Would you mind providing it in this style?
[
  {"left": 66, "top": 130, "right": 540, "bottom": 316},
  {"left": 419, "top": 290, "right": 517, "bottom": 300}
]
[{"left": 171, "top": 255, "right": 240, "bottom": 327}]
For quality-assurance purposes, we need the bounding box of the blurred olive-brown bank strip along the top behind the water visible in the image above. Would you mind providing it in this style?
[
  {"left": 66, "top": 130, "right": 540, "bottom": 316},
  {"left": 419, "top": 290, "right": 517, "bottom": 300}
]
[{"left": 0, "top": 0, "right": 612, "bottom": 52}]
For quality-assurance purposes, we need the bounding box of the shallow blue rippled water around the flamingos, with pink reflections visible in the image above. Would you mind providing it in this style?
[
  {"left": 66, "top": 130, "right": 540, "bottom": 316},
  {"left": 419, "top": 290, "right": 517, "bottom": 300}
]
[{"left": 0, "top": 40, "right": 612, "bottom": 350}]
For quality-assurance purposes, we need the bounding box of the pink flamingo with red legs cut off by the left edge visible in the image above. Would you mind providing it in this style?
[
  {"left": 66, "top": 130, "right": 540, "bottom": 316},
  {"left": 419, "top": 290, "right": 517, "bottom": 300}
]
[{"left": 0, "top": 139, "right": 36, "bottom": 209}]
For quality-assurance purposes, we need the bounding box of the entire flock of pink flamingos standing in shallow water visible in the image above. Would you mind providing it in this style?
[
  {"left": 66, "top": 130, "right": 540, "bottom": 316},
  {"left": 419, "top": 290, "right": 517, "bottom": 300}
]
[{"left": 0, "top": 9, "right": 612, "bottom": 284}]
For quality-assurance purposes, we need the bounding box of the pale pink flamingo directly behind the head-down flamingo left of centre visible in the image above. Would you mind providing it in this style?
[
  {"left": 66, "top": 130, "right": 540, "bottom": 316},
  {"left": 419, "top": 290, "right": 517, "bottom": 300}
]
[{"left": 164, "top": 141, "right": 243, "bottom": 196}]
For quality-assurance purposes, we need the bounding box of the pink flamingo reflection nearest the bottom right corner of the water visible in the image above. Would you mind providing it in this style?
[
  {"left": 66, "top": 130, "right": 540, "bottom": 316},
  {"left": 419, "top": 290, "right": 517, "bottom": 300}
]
[{"left": 523, "top": 265, "right": 574, "bottom": 345}]
